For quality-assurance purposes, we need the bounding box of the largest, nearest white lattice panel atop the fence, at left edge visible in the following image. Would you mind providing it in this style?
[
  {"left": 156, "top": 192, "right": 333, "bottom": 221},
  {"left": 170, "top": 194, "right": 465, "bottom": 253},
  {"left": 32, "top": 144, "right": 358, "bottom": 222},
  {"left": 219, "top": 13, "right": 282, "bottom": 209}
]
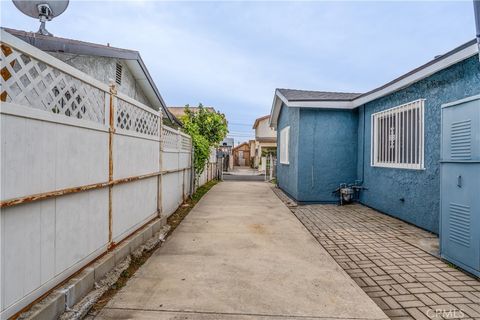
[{"left": 0, "top": 43, "right": 105, "bottom": 123}]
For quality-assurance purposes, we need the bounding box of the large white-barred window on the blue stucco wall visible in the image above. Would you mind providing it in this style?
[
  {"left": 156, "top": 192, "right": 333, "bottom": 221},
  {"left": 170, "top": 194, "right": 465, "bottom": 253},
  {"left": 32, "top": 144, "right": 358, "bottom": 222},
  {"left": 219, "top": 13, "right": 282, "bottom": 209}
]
[{"left": 371, "top": 99, "right": 425, "bottom": 169}]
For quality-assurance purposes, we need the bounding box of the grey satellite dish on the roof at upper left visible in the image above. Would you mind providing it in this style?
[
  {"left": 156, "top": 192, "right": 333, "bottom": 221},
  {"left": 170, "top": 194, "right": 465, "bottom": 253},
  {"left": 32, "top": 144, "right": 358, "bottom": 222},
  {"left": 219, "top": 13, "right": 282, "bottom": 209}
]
[{"left": 12, "top": 0, "right": 69, "bottom": 36}]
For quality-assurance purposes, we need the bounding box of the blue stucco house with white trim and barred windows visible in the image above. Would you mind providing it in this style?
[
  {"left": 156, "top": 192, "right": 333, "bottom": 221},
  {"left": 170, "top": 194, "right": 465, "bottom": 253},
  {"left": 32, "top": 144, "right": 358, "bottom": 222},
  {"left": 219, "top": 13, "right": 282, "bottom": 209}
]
[{"left": 270, "top": 40, "right": 480, "bottom": 233}]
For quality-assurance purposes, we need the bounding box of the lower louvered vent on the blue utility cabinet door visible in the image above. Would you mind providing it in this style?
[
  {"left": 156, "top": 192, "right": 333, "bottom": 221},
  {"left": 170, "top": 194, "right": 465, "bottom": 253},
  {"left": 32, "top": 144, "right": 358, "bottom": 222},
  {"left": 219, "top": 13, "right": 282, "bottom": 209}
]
[{"left": 448, "top": 202, "right": 471, "bottom": 248}]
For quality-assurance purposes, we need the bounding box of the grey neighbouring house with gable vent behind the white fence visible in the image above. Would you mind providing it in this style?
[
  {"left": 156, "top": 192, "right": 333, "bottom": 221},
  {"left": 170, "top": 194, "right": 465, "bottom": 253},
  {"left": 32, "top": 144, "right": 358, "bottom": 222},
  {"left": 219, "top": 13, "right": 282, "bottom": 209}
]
[{"left": 3, "top": 28, "right": 179, "bottom": 124}]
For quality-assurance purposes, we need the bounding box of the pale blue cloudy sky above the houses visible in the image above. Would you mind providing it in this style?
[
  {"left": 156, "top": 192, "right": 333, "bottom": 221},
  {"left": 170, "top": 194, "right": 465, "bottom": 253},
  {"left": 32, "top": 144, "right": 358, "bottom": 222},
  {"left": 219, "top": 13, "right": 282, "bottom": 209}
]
[{"left": 1, "top": 0, "right": 475, "bottom": 142}]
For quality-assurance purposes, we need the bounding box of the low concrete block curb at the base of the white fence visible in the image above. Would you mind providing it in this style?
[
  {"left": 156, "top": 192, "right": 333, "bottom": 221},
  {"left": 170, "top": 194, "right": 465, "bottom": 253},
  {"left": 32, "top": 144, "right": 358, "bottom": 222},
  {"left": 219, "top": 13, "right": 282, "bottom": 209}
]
[{"left": 18, "top": 217, "right": 167, "bottom": 320}]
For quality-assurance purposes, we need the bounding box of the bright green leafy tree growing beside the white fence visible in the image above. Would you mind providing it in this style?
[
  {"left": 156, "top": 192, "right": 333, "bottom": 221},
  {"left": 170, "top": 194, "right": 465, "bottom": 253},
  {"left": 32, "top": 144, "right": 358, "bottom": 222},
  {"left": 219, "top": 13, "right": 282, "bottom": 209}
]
[{"left": 181, "top": 104, "right": 228, "bottom": 175}]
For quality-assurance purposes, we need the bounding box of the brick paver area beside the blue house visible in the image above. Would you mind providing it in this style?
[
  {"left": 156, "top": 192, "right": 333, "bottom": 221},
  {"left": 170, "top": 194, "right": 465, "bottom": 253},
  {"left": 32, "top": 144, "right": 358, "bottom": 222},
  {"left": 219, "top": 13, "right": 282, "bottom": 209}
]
[{"left": 282, "top": 199, "right": 480, "bottom": 320}]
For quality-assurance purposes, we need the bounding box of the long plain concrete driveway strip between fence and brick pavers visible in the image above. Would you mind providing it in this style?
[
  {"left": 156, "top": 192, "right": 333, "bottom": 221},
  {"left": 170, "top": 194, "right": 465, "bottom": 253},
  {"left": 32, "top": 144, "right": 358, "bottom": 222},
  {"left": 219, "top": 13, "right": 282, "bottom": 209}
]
[{"left": 96, "top": 182, "right": 388, "bottom": 320}]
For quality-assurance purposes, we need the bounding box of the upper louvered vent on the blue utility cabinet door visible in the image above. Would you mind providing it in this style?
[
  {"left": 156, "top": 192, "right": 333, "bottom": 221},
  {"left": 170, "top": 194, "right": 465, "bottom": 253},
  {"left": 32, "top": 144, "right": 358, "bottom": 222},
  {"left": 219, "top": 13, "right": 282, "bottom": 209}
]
[{"left": 450, "top": 120, "right": 472, "bottom": 160}]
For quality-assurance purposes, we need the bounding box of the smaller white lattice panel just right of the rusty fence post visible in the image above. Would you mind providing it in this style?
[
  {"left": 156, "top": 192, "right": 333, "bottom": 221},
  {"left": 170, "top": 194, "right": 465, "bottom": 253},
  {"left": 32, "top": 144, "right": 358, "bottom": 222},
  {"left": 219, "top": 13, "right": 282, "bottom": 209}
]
[{"left": 117, "top": 99, "right": 159, "bottom": 136}]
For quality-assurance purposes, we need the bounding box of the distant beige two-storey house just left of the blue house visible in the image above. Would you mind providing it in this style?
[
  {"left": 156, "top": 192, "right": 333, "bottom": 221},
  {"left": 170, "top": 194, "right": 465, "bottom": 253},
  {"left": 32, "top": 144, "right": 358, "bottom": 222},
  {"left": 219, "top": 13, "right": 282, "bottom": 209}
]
[{"left": 251, "top": 115, "right": 277, "bottom": 167}]
